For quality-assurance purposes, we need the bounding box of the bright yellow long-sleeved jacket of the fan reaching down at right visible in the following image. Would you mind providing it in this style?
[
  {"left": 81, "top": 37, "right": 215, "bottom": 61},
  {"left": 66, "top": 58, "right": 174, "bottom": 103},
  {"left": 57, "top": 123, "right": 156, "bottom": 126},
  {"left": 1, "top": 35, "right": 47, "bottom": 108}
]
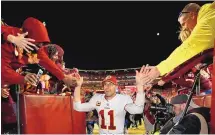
[{"left": 156, "top": 2, "right": 215, "bottom": 76}]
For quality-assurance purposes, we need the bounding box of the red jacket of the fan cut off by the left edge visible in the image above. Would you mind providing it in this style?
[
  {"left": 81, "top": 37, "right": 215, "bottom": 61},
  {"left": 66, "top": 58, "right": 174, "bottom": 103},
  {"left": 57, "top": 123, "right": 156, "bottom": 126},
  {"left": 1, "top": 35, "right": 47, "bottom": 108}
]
[{"left": 1, "top": 26, "right": 25, "bottom": 84}]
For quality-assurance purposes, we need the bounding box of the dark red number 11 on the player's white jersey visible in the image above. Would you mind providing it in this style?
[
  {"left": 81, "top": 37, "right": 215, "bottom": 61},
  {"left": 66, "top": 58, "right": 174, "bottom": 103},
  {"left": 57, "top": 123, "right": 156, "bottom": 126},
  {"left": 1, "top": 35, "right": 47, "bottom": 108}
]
[{"left": 99, "top": 110, "right": 116, "bottom": 130}]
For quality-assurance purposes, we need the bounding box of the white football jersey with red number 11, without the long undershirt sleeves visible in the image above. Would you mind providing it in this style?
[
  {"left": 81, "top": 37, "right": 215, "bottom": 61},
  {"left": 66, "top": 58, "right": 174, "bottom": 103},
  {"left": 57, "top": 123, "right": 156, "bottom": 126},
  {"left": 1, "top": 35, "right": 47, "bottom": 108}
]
[{"left": 92, "top": 94, "right": 133, "bottom": 134}]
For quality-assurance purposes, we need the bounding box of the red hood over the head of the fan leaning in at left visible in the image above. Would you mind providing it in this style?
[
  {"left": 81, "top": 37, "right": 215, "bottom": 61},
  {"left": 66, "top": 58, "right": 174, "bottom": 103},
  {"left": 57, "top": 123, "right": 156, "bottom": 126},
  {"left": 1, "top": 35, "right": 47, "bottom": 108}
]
[{"left": 22, "top": 17, "right": 50, "bottom": 43}]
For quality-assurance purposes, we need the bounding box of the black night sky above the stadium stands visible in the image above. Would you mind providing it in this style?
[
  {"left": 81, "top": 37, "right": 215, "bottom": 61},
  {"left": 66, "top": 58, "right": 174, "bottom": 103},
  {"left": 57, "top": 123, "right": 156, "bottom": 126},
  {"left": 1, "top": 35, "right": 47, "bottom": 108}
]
[{"left": 1, "top": 1, "right": 209, "bottom": 69}]
